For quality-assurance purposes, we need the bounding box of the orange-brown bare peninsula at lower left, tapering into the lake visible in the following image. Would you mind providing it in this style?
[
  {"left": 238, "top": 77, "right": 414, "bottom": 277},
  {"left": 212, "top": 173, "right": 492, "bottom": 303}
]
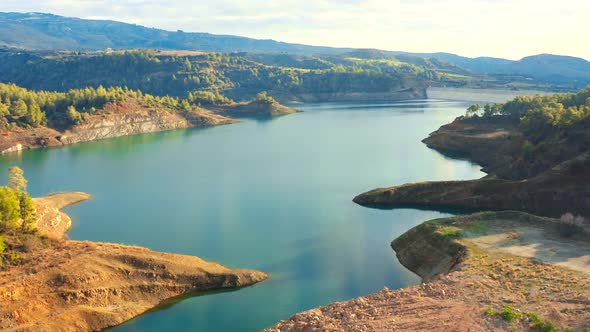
[{"left": 0, "top": 193, "right": 268, "bottom": 331}]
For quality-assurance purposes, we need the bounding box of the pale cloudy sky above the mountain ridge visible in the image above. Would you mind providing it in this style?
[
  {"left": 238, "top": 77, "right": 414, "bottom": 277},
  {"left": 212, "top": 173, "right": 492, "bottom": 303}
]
[{"left": 0, "top": 0, "right": 590, "bottom": 59}]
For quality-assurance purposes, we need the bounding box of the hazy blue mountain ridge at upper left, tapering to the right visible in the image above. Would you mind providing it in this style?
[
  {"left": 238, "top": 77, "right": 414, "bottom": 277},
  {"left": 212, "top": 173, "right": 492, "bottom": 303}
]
[{"left": 0, "top": 13, "right": 343, "bottom": 54}]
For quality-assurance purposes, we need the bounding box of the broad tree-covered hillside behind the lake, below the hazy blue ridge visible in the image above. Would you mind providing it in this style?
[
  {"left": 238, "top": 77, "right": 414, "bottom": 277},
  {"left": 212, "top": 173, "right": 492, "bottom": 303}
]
[{"left": 0, "top": 50, "right": 471, "bottom": 100}]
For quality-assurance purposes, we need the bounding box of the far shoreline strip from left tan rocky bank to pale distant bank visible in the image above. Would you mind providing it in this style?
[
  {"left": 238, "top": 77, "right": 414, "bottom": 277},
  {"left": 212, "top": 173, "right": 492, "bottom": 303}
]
[{"left": 0, "top": 87, "right": 545, "bottom": 155}]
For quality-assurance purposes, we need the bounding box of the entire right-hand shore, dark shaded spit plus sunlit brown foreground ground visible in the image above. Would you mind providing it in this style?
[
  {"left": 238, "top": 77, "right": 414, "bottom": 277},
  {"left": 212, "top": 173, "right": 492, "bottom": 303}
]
[{"left": 268, "top": 113, "right": 590, "bottom": 332}]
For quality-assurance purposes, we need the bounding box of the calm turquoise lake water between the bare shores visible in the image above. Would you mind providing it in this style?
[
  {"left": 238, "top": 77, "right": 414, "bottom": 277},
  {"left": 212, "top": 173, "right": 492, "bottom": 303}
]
[{"left": 0, "top": 100, "right": 483, "bottom": 331}]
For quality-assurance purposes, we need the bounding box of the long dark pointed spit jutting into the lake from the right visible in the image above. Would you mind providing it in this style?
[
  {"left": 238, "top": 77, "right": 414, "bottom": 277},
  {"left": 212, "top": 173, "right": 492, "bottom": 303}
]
[{"left": 353, "top": 155, "right": 590, "bottom": 217}]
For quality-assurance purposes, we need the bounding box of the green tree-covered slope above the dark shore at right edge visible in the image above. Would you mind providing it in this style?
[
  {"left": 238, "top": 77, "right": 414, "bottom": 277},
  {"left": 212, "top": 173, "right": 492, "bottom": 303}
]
[{"left": 464, "top": 87, "right": 590, "bottom": 173}]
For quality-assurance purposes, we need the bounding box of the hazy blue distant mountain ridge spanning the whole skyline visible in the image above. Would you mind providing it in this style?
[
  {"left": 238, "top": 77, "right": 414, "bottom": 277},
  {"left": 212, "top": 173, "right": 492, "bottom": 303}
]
[{"left": 0, "top": 13, "right": 590, "bottom": 90}]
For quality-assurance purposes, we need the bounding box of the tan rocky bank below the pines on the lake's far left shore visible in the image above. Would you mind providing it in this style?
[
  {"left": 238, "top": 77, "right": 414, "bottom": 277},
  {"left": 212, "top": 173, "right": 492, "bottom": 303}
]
[{"left": 0, "top": 100, "right": 298, "bottom": 155}]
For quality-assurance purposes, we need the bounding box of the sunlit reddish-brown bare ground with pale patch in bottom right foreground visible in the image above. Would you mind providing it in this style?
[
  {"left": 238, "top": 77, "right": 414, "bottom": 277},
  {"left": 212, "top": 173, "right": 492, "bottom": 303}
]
[{"left": 267, "top": 212, "right": 590, "bottom": 331}]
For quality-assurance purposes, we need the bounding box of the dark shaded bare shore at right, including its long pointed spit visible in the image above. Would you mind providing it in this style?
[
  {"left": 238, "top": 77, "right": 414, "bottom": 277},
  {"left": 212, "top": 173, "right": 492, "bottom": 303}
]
[{"left": 353, "top": 119, "right": 590, "bottom": 216}]
